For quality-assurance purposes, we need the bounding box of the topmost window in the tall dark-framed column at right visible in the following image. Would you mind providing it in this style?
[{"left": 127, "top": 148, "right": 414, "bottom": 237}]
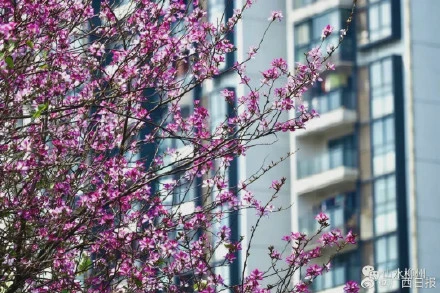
[{"left": 370, "top": 58, "right": 394, "bottom": 119}]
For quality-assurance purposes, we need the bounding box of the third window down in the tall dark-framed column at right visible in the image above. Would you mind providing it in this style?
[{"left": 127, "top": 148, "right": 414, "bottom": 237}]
[{"left": 374, "top": 175, "right": 397, "bottom": 235}]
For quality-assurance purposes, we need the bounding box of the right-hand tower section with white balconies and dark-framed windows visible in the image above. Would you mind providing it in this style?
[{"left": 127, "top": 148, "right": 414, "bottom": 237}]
[{"left": 286, "top": 0, "right": 440, "bottom": 292}]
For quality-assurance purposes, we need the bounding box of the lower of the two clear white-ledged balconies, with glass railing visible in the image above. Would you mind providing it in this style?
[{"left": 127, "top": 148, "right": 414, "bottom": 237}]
[{"left": 294, "top": 148, "right": 358, "bottom": 194}]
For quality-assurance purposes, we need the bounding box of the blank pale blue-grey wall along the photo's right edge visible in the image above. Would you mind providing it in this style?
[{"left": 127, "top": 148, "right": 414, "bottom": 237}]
[{"left": 408, "top": 0, "right": 440, "bottom": 292}]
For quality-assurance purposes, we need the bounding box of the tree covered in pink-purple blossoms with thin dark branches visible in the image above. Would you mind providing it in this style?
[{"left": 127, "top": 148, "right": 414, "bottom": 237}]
[{"left": 0, "top": 0, "right": 359, "bottom": 293}]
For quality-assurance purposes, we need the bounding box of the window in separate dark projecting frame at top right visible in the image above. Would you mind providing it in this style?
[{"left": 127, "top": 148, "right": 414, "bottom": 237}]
[{"left": 357, "top": 0, "right": 400, "bottom": 45}]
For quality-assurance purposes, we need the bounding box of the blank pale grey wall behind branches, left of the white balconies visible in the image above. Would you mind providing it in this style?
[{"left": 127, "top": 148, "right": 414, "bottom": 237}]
[{"left": 234, "top": 0, "right": 292, "bottom": 284}]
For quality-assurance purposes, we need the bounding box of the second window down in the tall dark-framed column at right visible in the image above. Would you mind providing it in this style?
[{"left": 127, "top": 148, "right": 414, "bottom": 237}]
[{"left": 371, "top": 116, "right": 396, "bottom": 176}]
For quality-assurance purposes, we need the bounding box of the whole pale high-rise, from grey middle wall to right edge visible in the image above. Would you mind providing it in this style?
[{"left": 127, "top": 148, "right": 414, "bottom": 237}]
[{"left": 109, "top": 0, "right": 440, "bottom": 292}]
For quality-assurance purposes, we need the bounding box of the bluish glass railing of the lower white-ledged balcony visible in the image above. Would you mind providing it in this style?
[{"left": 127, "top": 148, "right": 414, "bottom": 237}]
[{"left": 297, "top": 148, "right": 356, "bottom": 179}]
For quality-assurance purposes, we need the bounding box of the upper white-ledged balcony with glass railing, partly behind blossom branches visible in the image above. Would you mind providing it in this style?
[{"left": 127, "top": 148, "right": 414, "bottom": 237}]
[{"left": 296, "top": 89, "right": 357, "bottom": 137}]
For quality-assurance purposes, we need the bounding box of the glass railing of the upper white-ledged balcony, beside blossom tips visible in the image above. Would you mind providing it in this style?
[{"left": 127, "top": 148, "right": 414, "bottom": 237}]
[{"left": 308, "top": 89, "right": 354, "bottom": 114}]
